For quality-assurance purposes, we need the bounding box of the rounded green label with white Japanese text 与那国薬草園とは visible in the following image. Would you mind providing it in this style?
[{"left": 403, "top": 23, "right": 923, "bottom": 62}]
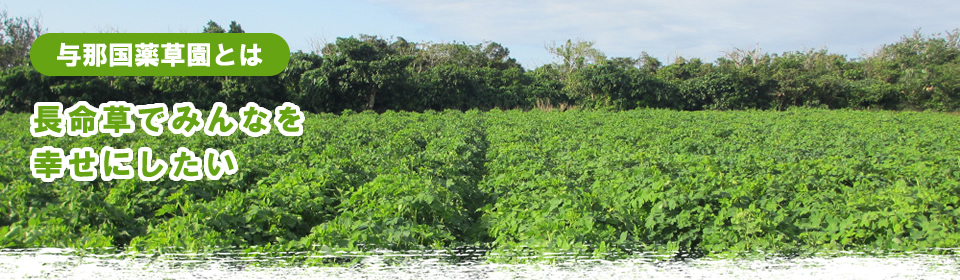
[{"left": 30, "top": 33, "right": 290, "bottom": 76}]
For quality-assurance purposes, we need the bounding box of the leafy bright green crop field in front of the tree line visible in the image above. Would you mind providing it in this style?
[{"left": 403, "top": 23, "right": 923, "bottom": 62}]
[{"left": 0, "top": 110, "right": 960, "bottom": 254}]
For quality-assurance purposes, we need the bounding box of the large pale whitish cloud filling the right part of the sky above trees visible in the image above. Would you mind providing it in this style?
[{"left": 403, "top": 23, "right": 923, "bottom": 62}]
[{"left": 372, "top": 0, "right": 960, "bottom": 66}]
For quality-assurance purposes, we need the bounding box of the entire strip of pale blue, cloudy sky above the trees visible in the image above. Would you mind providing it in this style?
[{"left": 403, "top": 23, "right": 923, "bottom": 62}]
[{"left": 7, "top": 0, "right": 960, "bottom": 68}]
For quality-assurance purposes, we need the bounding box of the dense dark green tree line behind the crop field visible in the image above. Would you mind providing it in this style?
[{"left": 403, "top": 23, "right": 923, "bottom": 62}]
[{"left": 0, "top": 14, "right": 960, "bottom": 112}]
